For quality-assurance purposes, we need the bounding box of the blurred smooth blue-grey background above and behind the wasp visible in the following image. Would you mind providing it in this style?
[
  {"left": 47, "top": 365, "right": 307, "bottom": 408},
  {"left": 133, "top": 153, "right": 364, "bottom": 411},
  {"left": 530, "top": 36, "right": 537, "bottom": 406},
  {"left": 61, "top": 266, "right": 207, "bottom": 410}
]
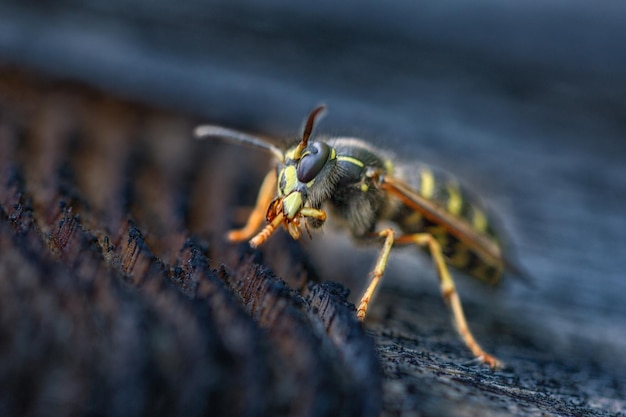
[{"left": 0, "top": 0, "right": 626, "bottom": 407}]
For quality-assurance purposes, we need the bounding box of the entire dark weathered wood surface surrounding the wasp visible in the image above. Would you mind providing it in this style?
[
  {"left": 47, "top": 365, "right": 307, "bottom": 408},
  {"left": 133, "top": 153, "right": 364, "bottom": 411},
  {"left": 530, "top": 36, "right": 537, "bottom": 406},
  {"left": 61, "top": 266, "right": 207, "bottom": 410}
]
[{"left": 0, "top": 1, "right": 626, "bottom": 415}]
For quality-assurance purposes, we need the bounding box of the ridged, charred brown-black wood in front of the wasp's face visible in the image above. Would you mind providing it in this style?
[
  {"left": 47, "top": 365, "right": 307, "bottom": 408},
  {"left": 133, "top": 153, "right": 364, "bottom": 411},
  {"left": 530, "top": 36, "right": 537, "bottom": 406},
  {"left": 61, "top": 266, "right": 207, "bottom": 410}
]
[{"left": 0, "top": 72, "right": 381, "bottom": 416}]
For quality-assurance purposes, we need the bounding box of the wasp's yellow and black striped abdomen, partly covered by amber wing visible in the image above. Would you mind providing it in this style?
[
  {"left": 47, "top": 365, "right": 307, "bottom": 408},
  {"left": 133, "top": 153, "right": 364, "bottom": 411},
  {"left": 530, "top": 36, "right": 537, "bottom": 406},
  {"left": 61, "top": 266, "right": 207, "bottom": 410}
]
[{"left": 391, "top": 164, "right": 504, "bottom": 284}]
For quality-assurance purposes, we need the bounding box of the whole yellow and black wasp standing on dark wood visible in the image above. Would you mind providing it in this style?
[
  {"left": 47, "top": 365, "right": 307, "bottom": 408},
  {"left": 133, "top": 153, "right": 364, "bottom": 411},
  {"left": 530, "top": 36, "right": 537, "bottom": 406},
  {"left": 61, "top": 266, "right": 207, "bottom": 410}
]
[{"left": 195, "top": 106, "right": 511, "bottom": 368}]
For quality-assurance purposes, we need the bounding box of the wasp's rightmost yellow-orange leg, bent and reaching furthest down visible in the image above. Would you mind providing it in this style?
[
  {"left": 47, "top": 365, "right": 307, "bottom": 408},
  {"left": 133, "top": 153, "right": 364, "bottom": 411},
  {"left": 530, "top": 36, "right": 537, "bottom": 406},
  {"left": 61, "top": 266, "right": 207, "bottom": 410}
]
[{"left": 396, "top": 233, "right": 502, "bottom": 368}]
